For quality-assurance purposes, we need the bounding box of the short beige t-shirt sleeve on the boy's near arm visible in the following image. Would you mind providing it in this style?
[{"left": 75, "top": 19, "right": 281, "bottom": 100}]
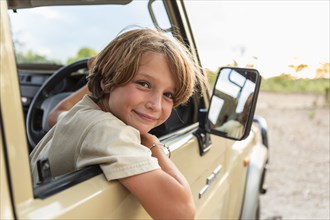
[{"left": 76, "top": 120, "right": 160, "bottom": 180}]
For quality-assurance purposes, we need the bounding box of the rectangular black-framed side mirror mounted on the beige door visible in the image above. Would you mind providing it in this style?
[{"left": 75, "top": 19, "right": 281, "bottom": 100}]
[{"left": 207, "top": 67, "right": 261, "bottom": 140}]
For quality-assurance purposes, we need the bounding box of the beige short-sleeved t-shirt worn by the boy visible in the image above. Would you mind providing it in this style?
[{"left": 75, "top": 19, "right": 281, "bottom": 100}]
[{"left": 30, "top": 95, "right": 160, "bottom": 183}]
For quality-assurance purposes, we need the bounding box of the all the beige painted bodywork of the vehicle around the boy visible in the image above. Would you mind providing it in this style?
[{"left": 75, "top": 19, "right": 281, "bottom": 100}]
[{"left": 0, "top": 1, "right": 263, "bottom": 219}]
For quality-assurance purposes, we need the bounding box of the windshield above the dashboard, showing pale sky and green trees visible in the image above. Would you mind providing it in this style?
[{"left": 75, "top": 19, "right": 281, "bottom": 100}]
[{"left": 9, "top": 0, "right": 170, "bottom": 64}]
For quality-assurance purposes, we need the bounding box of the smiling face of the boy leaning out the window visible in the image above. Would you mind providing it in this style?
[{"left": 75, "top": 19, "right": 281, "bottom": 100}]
[{"left": 107, "top": 52, "right": 175, "bottom": 134}]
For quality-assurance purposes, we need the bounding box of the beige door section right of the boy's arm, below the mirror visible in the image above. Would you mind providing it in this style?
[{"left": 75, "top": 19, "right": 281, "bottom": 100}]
[{"left": 167, "top": 127, "right": 231, "bottom": 219}]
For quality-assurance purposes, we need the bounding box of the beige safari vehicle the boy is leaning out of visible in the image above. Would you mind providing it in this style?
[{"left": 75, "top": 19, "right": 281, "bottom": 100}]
[{"left": 0, "top": 0, "right": 268, "bottom": 219}]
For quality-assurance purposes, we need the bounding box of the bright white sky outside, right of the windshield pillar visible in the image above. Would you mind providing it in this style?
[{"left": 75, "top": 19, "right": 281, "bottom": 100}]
[{"left": 187, "top": 0, "right": 330, "bottom": 77}]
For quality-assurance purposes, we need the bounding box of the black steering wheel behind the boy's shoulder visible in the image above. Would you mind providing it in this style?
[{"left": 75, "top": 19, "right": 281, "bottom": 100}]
[{"left": 26, "top": 59, "right": 88, "bottom": 149}]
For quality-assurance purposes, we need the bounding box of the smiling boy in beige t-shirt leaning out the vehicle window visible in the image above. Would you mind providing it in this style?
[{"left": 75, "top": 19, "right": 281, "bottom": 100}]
[{"left": 30, "top": 29, "right": 205, "bottom": 219}]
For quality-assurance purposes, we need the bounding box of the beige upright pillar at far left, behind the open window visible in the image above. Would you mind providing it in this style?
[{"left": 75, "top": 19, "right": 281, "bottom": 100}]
[{"left": 0, "top": 1, "right": 33, "bottom": 210}]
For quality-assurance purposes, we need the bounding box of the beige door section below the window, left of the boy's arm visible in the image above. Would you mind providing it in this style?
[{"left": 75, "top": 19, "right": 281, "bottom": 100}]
[{"left": 19, "top": 174, "right": 150, "bottom": 219}]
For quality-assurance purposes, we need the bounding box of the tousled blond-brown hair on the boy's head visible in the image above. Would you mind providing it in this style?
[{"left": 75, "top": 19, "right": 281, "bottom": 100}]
[{"left": 88, "top": 28, "right": 203, "bottom": 107}]
